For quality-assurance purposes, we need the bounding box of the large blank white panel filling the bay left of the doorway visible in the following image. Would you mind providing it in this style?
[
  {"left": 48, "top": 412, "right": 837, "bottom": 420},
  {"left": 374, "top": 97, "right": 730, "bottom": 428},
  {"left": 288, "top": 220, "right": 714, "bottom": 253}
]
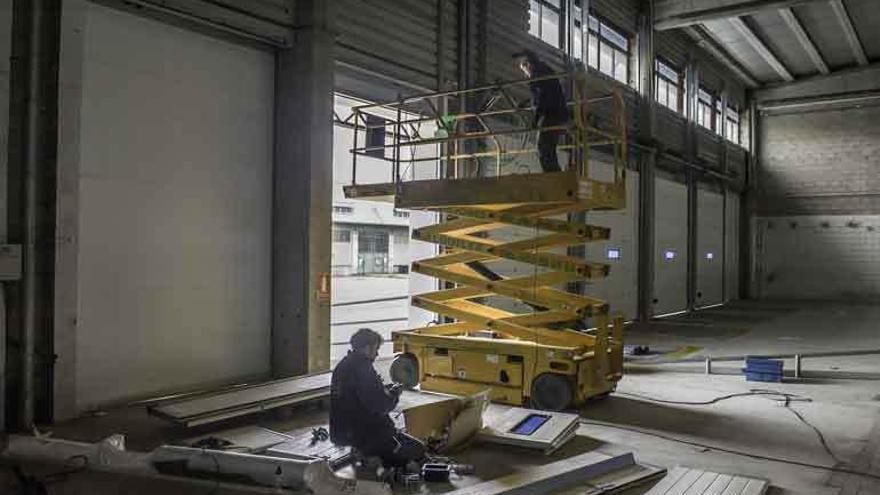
[{"left": 76, "top": 3, "right": 274, "bottom": 410}]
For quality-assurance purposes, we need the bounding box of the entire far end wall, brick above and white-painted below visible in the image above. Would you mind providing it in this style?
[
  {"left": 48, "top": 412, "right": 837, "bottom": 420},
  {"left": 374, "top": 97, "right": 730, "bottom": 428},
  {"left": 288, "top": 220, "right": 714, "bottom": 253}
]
[{"left": 756, "top": 106, "right": 880, "bottom": 299}]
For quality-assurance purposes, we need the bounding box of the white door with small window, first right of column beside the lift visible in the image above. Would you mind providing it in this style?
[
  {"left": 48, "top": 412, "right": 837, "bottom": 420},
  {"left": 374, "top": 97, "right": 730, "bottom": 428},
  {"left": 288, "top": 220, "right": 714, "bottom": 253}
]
[{"left": 653, "top": 177, "right": 687, "bottom": 315}]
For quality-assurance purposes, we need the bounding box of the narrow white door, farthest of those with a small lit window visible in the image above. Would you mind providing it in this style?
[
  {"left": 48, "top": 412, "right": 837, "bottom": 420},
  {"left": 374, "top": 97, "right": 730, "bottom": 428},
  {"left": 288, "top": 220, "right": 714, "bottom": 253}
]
[{"left": 696, "top": 189, "right": 724, "bottom": 307}]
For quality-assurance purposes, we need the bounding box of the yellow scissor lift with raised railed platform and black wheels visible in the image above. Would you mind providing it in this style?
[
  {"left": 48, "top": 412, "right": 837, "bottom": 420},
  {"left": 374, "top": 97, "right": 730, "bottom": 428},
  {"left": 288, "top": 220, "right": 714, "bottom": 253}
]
[{"left": 344, "top": 72, "right": 627, "bottom": 409}]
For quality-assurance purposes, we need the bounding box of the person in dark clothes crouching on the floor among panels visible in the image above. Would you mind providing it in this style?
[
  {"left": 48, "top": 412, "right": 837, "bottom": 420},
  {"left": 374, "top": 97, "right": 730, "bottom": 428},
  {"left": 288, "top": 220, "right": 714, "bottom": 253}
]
[{"left": 330, "top": 328, "right": 425, "bottom": 467}]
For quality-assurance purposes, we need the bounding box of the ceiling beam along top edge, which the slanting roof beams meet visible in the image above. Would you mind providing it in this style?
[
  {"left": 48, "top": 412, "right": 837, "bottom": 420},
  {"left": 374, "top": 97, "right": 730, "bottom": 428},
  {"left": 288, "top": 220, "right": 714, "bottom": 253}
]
[{"left": 654, "top": 0, "right": 820, "bottom": 31}]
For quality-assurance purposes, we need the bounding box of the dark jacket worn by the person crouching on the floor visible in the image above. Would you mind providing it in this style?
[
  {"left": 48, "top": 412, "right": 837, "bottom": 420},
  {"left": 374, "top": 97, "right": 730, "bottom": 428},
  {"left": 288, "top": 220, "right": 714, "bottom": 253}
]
[{"left": 330, "top": 351, "right": 398, "bottom": 448}]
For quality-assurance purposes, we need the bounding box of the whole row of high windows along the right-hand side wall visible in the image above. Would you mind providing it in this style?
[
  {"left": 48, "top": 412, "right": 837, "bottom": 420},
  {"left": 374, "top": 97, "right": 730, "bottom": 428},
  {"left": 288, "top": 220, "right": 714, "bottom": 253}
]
[{"left": 529, "top": 0, "right": 740, "bottom": 144}]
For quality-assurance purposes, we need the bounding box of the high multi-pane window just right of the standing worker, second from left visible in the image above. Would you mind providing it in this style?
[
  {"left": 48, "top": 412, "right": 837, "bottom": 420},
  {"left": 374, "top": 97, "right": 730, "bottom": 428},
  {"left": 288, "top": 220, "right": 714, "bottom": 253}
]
[{"left": 573, "top": 8, "right": 630, "bottom": 84}]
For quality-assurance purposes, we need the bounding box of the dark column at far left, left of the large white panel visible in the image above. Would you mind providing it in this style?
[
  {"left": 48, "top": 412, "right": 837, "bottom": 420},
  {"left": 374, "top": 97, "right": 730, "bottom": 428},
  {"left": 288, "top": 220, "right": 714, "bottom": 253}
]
[{"left": 6, "top": 0, "right": 61, "bottom": 429}]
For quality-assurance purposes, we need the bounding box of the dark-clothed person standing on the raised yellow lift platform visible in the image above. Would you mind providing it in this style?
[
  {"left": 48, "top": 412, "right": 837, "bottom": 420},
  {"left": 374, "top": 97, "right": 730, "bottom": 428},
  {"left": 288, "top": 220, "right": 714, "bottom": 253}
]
[{"left": 513, "top": 50, "right": 571, "bottom": 172}]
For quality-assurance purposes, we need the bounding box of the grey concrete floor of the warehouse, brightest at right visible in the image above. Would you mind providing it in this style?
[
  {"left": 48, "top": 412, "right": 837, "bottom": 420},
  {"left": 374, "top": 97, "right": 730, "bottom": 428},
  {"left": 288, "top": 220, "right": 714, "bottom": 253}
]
[{"left": 0, "top": 302, "right": 880, "bottom": 495}]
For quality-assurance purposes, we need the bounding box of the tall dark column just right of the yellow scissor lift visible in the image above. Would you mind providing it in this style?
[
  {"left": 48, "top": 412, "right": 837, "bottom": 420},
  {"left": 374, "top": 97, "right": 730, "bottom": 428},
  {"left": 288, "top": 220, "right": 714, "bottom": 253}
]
[{"left": 637, "top": 0, "right": 657, "bottom": 323}]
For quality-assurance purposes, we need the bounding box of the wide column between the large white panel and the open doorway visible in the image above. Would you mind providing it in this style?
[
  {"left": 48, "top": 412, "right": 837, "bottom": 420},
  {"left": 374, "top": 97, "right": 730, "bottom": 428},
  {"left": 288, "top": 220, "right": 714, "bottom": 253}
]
[{"left": 272, "top": 0, "right": 334, "bottom": 377}]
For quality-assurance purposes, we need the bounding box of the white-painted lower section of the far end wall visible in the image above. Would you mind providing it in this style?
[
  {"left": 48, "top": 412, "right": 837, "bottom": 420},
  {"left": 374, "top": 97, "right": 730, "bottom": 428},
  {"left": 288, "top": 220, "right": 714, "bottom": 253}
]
[{"left": 757, "top": 215, "right": 880, "bottom": 300}]
